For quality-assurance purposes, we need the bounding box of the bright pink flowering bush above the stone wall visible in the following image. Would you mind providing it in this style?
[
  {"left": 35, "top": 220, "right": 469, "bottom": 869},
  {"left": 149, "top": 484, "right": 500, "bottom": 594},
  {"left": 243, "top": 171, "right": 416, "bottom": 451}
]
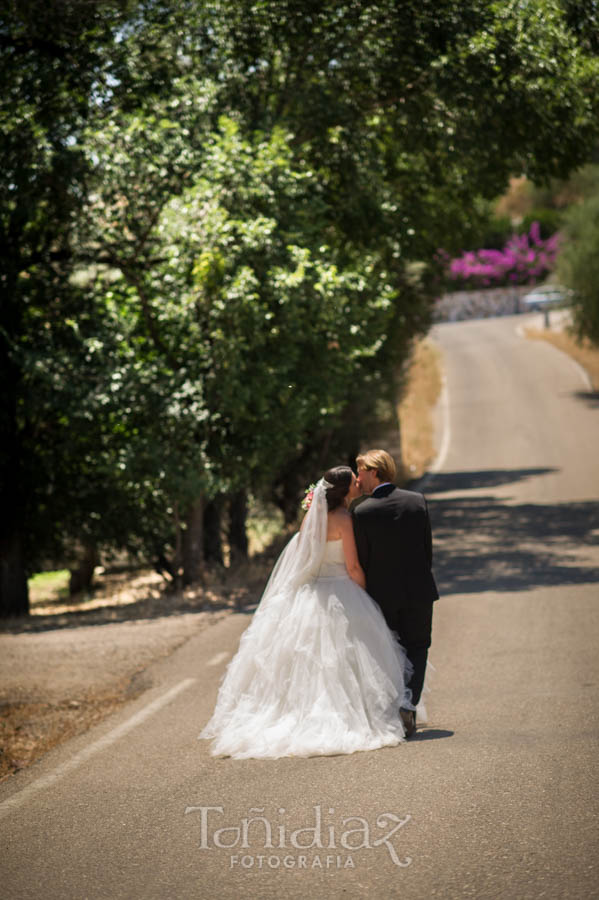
[{"left": 438, "top": 222, "right": 560, "bottom": 290}]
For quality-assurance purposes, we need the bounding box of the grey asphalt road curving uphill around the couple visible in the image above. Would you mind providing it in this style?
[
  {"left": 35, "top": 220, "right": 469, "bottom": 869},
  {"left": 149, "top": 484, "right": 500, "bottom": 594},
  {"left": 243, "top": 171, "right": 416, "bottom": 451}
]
[{"left": 0, "top": 317, "right": 599, "bottom": 900}]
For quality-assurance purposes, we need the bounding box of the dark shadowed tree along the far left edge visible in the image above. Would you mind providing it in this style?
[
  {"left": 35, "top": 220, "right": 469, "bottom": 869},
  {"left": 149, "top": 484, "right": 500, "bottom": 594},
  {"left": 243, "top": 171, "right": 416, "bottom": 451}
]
[{"left": 0, "top": 0, "right": 131, "bottom": 615}]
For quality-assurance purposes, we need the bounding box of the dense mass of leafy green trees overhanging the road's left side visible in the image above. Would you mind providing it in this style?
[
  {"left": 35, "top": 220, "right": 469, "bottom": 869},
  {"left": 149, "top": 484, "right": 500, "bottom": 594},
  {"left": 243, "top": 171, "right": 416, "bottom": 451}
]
[{"left": 0, "top": 0, "right": 599, "bottom": 615}]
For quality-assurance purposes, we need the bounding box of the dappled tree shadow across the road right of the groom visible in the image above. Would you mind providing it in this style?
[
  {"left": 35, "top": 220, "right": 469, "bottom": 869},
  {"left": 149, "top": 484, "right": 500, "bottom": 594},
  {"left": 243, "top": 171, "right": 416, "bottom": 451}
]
[{"left": 427, "top": 469, "right": 599, "bottom": 596}]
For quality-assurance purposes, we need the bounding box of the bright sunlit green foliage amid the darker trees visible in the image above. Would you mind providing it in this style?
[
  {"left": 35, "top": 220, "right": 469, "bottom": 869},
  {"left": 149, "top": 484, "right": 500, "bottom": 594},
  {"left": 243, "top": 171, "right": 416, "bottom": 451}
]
[{"left": 87, "top": 117, "right": 412, "bottom": 503}]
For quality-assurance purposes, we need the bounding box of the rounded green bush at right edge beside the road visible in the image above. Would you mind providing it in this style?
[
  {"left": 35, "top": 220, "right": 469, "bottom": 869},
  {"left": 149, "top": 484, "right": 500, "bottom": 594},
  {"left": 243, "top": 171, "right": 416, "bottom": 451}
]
[{"left": 557, "top": 193, "right": 599, "bottom": 346}]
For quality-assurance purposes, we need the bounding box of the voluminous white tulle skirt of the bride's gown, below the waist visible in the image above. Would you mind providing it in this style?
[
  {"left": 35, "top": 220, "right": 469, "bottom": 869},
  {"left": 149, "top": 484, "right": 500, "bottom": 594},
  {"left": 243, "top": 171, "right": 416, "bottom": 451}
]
[{"left": 200, "top": 575, "right": 410, "bottom": 759}]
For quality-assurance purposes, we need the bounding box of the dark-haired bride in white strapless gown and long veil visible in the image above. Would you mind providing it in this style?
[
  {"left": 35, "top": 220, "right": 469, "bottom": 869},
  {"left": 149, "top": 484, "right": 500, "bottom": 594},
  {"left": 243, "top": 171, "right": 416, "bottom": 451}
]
[{"left": 200, "top": 466, "right": 412, "bottom": 759}]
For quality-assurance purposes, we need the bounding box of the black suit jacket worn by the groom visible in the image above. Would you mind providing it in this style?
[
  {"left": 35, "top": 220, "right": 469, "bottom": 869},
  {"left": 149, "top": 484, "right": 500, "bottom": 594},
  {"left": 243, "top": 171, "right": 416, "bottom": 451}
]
[{"left": 353, "top": 484, "right": 439, "bottom": 621}]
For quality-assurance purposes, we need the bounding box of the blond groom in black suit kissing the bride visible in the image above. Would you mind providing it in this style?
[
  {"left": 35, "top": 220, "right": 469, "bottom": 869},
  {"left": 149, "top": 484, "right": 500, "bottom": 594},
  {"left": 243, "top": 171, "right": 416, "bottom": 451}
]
[{"left": 353, "top": 450, "right": 439, "bottom": 737}]
